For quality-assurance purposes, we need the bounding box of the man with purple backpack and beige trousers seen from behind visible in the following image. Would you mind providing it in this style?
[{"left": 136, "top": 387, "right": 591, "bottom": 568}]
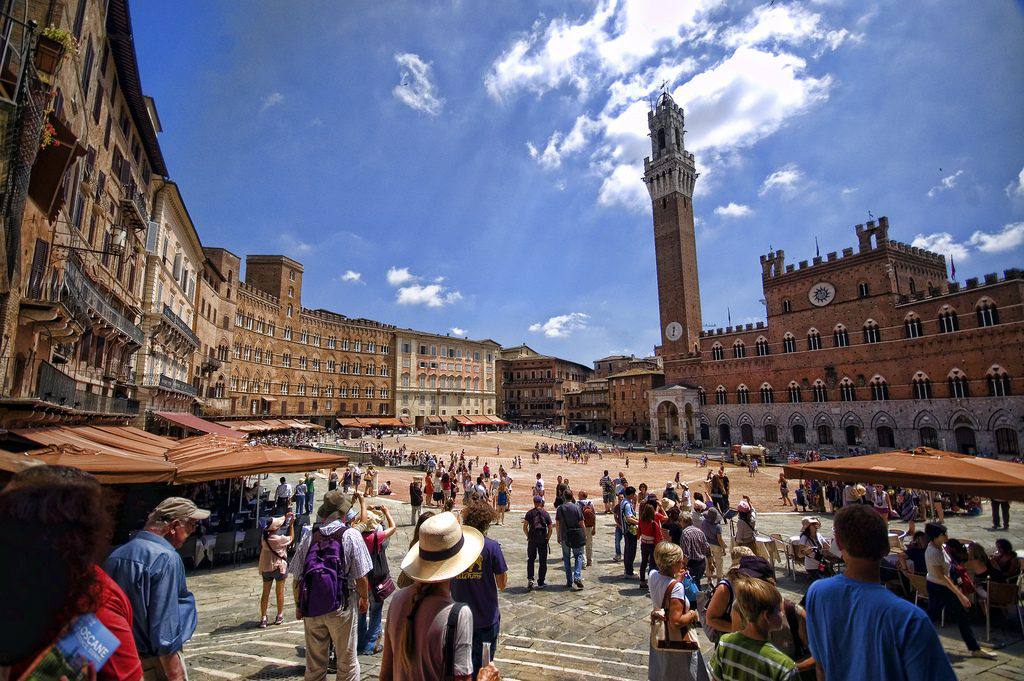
[{"left": 288, "top": 486, "right": 373, "bottom": 681}]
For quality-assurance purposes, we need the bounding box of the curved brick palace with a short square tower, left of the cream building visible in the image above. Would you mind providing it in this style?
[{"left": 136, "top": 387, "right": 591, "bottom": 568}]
[{"left": 227, "top": 255, "right": 394, "bottom": 425}]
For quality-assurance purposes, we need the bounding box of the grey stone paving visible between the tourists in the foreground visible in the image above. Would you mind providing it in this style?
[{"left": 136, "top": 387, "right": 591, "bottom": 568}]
[{"left": 185, "top": 440, "right": 1024, "bottom": 681}]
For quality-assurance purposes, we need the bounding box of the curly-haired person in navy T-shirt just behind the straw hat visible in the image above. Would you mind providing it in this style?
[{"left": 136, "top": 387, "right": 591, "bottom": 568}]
[{"left": 452, "top": 502, "right": 509, "bottom": 674}]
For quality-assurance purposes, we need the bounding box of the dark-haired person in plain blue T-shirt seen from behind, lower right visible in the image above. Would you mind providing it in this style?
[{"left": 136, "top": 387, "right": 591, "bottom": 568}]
[{"left": 807, "top": 504, "right": 956, "bottom": 681}]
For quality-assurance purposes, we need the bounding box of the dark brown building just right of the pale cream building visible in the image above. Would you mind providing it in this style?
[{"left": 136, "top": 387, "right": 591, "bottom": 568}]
[{"left": 499, "top": 344, "right": 593, "bottom": 428}]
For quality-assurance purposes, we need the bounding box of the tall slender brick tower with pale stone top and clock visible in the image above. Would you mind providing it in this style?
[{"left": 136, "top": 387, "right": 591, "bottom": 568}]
[{"left": 643, "top": 92, "right": 700, "bottom": 355}]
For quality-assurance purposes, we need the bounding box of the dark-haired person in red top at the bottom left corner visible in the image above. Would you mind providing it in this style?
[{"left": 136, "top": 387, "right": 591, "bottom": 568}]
[{"left": 0, "top": 466, "right": 142, "bottom": 681}]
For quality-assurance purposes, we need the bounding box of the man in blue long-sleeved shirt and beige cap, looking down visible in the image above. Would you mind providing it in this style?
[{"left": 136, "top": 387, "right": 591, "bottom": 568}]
[{"left": 103, "top": 497, "right": 210, "bottom": 681}]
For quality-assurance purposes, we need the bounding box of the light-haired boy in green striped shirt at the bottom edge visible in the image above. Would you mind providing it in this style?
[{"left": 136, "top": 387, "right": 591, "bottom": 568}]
[{"left": 710, "top": 578, "right": 797, "bottom": 681}]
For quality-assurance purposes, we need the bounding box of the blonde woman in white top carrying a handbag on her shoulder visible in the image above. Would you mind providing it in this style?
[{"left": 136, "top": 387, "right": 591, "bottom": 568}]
[{"left": 647, "top": 542, "right": 709, "bottom": 681}]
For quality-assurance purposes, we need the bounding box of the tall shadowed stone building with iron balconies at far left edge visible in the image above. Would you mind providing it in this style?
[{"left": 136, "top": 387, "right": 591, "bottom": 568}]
[{"left": 0, "top": 0, "right": 167, "bottom": 427}]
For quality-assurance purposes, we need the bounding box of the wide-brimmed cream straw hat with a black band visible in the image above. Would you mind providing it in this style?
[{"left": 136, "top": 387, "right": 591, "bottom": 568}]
[{"left": 401, "top": 512, "right": 483, "bottom": 583}]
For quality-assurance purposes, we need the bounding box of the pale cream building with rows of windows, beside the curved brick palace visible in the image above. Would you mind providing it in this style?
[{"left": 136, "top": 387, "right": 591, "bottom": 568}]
[{"left": 394, "top": 329, "right": 501, "bottom": 428}]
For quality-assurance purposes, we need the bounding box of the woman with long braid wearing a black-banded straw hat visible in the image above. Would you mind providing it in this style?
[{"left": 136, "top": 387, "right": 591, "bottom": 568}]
[{"left": 380, "top": 513, "right": 501, "bottom": 681}]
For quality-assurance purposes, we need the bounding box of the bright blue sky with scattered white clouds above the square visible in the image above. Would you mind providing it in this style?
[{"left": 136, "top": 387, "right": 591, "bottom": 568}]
[{"left": 132, "top": 0, "right": 1024, "bottom": 363}]
